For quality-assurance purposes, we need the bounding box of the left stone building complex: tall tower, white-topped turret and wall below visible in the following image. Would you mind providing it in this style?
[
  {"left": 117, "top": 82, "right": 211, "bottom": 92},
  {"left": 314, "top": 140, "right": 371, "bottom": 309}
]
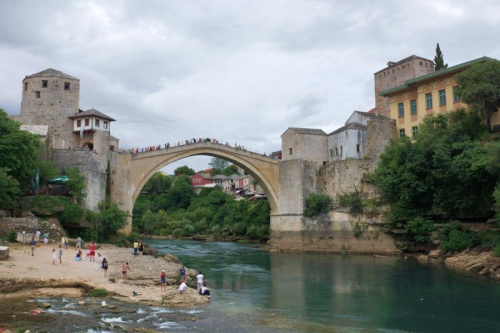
[{"left": 10, "top": 68, "right": 119, "bottom": 209}]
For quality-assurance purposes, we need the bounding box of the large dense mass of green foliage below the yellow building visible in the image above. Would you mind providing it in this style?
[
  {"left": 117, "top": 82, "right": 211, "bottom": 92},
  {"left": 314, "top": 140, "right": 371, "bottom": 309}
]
[{"left": 375, "top": 110, "right": 498, "bottom": 220}]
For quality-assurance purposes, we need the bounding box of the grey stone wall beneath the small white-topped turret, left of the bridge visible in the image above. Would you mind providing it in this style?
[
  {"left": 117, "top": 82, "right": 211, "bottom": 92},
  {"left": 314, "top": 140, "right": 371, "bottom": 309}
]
[{"left": 51, "top": 149, "right": 107, "bottom": 210}]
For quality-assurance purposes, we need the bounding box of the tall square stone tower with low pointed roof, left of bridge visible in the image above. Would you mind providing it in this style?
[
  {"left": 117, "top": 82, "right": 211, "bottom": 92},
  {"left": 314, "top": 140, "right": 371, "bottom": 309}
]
[{"left": 16, "top": 68, "right": 80, "bottom": 149}]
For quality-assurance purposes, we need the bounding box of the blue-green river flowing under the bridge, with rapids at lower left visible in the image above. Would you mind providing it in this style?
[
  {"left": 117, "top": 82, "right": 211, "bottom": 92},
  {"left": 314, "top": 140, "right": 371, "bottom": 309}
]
[{"left": 0, "top": 240, "right": 500, "bottom": 333}]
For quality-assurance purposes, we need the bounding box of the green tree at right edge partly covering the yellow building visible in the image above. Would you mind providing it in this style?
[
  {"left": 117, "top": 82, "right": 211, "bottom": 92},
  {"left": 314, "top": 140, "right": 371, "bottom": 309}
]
[{"left": 455, "top": 60, "right": 500, "bottom": 129}]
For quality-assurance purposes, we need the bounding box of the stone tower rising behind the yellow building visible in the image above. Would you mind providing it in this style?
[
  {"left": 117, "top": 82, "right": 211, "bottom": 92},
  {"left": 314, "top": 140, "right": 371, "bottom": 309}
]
[{"left": 373, "top": 55, "right": 434, "bottom": 118}]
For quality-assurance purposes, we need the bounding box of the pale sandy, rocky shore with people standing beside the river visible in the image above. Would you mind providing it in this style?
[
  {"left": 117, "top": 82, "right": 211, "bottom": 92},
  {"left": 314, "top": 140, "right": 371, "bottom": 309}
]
[{"left": 0, "top": 243, "right": 210, "bottom": 307}]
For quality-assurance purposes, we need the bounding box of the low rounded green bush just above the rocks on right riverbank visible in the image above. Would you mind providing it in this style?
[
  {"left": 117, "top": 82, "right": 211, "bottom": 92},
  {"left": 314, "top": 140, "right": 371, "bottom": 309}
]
[{"left": 440, "top": 221, "right": 481, "bottom": 251}]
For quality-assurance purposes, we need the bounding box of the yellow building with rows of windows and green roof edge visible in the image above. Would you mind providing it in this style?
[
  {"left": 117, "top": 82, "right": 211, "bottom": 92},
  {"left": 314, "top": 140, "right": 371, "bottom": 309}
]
[{"left": 379, "top": 57, "right": 500, "bottom": 138}]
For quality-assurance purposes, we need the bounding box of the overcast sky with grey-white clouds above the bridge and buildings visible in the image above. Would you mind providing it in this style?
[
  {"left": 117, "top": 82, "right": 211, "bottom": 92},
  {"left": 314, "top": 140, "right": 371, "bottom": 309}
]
[{"left": 0, "top": 0, "right": 500, "bottom": 171}]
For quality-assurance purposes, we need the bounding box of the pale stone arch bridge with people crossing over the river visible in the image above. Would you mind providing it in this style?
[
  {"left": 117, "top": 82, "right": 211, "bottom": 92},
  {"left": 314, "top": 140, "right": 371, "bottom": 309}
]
[{"left": 110, "top": 142, "right": 279, "bottom": 234}]
